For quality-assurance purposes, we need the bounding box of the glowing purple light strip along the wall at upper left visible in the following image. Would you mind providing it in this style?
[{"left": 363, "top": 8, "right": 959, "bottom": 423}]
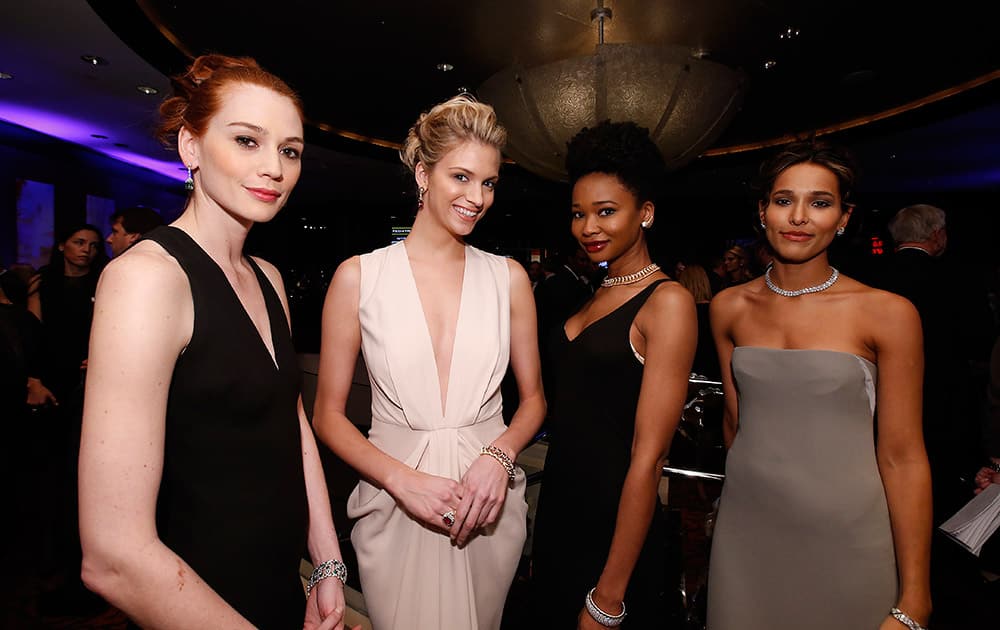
[{"left": 0, "top": 102, "right": 187, "bottom": 181}]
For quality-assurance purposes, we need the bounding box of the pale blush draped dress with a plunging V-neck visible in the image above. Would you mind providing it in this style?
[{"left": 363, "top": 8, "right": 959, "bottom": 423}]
[{"left": 347, "top": 242, "right": 527, "bottom": 630}]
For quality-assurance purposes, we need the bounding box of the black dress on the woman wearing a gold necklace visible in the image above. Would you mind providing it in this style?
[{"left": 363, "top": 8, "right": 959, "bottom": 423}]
[{"left": 531, "top": 280, "right": 667, "bottom": 630}]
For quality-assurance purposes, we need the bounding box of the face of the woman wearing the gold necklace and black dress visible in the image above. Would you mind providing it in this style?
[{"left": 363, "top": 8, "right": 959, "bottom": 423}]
[{"left": 570, "top": 173, "right": 654, "bottom": 263}]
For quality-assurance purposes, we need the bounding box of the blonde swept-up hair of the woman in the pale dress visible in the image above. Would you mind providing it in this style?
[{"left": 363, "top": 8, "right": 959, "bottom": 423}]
[{"left": 399, "top": 94, "right": 507, "bottom": 178}]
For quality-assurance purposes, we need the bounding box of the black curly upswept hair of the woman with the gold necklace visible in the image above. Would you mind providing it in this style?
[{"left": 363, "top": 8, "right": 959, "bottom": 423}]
[{"left": 566, "top": 120, "right": 666, "bottom": 204}]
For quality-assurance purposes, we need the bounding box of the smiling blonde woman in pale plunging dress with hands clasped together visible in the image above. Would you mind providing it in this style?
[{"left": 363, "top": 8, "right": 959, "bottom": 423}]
[{"left": 313, "top": 95, "right": 545, "bottom": 630}]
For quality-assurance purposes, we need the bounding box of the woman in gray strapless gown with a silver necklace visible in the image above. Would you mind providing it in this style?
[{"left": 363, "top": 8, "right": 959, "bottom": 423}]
[{"left": 708, "top": 142, "right": 931, "bottom": 630}]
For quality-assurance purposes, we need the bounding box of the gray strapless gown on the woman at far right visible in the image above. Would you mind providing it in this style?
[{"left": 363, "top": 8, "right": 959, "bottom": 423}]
[{"left": 707, "top": 347, "right": 898, "bottom": 630}]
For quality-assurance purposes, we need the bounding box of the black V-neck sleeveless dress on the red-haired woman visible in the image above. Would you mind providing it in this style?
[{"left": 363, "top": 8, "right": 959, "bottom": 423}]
[{"left": 139, "top": 226, "right": 309, "bottom": 630}]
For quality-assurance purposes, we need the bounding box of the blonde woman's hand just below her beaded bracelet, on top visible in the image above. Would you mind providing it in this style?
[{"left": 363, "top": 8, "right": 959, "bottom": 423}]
[{"left": 451, "top": 455, "right": 508, "bottom": 547}]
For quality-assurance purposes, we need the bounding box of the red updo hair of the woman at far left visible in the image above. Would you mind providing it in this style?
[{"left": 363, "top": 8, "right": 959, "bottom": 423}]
[{"left": 156, "top": 54, "right": 305, "bottom": 146}]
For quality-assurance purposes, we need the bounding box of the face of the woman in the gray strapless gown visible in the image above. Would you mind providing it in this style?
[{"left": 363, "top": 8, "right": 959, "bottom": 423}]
[{"left": 760, "top": 162, "right": 851, "bottom": 262}]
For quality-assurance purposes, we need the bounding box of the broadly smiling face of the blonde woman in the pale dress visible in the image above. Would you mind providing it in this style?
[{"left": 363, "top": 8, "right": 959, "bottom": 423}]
[{"left": 415, "top": 140, "right": 500, "bottom": 236}]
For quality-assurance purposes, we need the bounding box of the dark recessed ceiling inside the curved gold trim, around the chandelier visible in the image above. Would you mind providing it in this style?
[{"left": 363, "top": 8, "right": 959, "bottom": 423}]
[{"left": 99, "top": 0, "right": 1000, "bottom": 165}]
